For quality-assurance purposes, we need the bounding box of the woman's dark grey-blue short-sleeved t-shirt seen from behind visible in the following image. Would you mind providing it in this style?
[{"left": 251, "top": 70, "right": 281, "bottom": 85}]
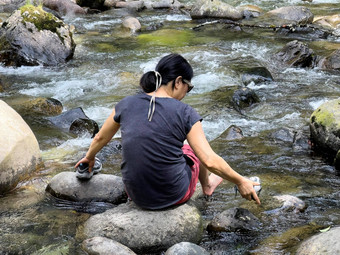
[{"left": 114, "top": 93, "right": 202, "bottom": 209}]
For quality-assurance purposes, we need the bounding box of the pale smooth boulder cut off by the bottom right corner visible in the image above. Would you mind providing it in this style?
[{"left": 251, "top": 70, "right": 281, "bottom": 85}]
[{"left": 296, "top": 227, "right": 340, "bottom": 255}]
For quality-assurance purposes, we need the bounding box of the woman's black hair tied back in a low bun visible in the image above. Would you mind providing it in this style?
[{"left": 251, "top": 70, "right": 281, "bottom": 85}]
[{"left": 139, "top": 54, "right": 194, "bottom": 93}]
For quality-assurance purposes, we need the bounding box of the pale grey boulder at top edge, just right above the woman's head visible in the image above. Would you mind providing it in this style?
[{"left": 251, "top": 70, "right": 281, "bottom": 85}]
[{"left": 190, "top": 0, "right": 243, "bottom": 20}]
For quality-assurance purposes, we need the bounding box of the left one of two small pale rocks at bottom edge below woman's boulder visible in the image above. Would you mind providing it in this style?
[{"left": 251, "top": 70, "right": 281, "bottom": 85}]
[{"left": 82, "top": 236, "right": 136, "bottom": 255}]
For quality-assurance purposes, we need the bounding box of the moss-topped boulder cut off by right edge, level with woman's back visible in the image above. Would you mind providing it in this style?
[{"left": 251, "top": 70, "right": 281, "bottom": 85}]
[{"left": 310, "top": 99, "right": 340, "bottom": 166}]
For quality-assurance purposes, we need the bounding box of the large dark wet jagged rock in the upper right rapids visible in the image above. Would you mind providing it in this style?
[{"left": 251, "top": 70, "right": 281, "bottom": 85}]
[{"left": 274, "top": 40, "right": 317, "bottom": 67}]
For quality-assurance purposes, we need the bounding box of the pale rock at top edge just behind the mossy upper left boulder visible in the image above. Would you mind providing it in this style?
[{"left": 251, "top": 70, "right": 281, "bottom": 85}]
[{"left": 43, "top": 0, "right": 86, "bottom": 15}]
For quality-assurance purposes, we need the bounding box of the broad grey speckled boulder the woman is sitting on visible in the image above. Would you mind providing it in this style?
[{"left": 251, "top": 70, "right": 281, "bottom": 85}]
[{"left": 78, "top": 202, "right": 203, "bottom": 253}]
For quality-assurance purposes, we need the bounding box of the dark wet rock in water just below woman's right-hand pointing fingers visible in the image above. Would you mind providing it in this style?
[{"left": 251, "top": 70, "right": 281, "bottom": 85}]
[{"left": 207, "top": 208, "right": 261, "bottom": 232}]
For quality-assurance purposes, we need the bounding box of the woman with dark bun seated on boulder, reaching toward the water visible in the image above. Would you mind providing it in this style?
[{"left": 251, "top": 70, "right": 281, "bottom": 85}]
[{"left": 75, "top": 54, "right": 260, "bottom": 209}]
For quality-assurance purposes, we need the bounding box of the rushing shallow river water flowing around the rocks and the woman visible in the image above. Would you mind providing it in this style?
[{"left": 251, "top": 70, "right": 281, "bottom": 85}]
[{"left": 0, "top": 0, "right": 340, "bottom": 254}]
